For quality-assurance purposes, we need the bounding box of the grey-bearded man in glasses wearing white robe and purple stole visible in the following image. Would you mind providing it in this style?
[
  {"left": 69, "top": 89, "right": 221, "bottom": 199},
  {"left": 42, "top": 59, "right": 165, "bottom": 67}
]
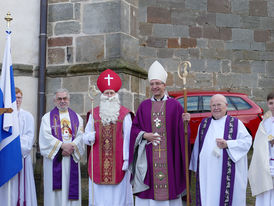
[{"left": 39, "top": 89, "right": 85, "bottom": 206}]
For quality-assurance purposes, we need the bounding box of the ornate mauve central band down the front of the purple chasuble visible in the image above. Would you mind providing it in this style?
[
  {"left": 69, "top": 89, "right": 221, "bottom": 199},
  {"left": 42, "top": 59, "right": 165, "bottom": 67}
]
[{"left": 151, "top": 101, "right": 169, "bottom": 200}]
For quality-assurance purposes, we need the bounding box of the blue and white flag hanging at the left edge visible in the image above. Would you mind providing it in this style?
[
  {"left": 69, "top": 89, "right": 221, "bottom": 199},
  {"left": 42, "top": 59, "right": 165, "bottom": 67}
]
[{"left": 0, "top": 31, "right": 22, "bottom": 187}]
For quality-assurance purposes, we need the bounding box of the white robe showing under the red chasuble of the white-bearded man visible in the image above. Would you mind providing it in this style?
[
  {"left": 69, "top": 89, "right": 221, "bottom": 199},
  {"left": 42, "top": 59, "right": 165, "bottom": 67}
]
[{"left": 83, "top": 114, "right": 133, "bottom": 206}]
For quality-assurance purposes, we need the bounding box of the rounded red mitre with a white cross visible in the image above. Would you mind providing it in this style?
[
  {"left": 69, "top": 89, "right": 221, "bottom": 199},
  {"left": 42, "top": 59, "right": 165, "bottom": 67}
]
[{"left": 97, "top": 69, "right": 122, "bottom": 93}]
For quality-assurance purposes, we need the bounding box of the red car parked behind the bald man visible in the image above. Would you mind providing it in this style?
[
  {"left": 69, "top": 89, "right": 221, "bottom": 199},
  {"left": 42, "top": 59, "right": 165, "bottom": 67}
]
[{"left": 168, "top": 91, "right": 263, "bottom": 144}]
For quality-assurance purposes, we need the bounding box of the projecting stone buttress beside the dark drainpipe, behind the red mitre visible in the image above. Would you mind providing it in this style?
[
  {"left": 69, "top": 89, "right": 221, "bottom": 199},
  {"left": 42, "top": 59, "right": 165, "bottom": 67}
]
[{"left": 47, "top": 0, "right": 147, "bottom": 115}]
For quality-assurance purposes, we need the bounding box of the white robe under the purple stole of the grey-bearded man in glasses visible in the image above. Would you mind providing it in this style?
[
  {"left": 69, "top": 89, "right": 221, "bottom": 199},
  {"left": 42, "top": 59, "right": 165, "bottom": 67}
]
[{"left": 39, "top": 112, "right": 85, "bottom": 206}]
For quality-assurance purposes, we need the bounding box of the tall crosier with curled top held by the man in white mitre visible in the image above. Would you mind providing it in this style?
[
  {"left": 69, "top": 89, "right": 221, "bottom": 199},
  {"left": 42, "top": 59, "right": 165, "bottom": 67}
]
[{"left": 178, "top": 61, "right": 191, "bottom": 206}]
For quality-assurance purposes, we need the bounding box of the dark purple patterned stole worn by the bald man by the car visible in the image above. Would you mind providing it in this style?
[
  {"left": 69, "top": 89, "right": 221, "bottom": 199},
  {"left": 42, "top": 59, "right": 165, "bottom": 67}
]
[{"left": 196, "top": 115, "right": 238, "bottom": 206}]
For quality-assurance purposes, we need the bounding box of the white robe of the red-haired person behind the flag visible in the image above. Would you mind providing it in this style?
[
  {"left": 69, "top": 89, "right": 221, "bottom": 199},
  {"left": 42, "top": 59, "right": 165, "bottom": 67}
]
[{"left": 0, "top": 109, "right": 37, "bottom": 206}]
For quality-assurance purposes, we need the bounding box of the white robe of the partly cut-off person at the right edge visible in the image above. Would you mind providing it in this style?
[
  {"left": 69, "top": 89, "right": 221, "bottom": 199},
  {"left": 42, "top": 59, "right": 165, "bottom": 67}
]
[{"left": 249, "top": 112, "right": 274, "bottom": 206}]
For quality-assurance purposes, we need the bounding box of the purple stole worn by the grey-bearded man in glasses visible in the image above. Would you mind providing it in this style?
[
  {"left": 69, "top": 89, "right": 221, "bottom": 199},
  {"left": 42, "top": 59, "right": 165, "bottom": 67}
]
[{"left": 50, "top": 107, "right": 79, "bottom": 200}]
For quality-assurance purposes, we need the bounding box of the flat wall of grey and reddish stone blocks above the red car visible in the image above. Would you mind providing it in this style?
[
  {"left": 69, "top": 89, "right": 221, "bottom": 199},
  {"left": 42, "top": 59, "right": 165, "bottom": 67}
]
[{"left": 138, "top": 0, "right": 274, "bottom": 108}]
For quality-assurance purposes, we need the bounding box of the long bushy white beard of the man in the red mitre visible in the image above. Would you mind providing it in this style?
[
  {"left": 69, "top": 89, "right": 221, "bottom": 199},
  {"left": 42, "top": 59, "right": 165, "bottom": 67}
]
[{"left": 99, "top": 93, "right": 120, "bottom": 126}]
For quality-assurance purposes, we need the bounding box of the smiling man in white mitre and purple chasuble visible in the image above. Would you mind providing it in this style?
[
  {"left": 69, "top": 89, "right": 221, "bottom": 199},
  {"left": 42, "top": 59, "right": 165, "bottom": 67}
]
[{"left": 129, "top": 61, "right": 190, "bottom": 206}]
